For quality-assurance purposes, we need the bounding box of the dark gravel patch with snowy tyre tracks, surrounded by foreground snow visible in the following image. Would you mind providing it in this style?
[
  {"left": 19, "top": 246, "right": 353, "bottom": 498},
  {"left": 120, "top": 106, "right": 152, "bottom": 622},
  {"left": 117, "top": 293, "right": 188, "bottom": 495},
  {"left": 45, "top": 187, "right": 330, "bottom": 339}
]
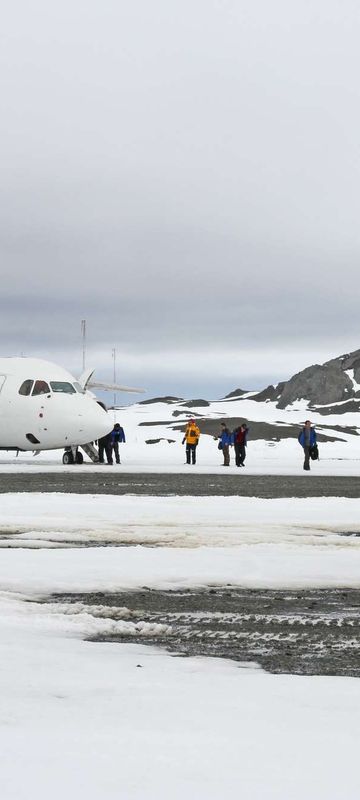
[{"left": 52, "top": 586, "right": 360, "bottom": 677}]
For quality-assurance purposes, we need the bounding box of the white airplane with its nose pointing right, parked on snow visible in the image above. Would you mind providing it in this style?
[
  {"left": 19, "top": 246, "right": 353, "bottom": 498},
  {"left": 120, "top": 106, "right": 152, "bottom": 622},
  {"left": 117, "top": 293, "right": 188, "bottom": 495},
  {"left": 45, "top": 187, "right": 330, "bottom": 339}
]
[{"left": 0, "top": 357, "right": 144, "bottom": 464}]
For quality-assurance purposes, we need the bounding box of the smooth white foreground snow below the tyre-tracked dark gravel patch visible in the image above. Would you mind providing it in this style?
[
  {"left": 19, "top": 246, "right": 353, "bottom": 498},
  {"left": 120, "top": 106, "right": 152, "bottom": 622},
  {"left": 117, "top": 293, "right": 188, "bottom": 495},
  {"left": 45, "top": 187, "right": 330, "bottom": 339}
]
[{"left": 0, "top": 606, "right": 360, "bottom": 800}]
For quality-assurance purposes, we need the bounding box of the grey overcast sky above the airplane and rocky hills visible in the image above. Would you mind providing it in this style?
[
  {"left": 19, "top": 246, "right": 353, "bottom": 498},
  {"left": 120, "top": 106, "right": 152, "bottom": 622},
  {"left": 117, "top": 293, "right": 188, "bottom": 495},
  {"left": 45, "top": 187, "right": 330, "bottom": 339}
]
[{"left": 0, "top": 0, "right": 360, "bottom": 397}]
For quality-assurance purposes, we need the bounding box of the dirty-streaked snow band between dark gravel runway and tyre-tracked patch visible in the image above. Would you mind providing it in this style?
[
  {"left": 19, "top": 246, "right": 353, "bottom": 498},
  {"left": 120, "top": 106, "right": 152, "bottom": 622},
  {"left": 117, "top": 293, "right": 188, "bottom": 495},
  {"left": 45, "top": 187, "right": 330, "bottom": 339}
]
[{"left": 0, "top": 494, "right": 360, "bottom": 595}]
